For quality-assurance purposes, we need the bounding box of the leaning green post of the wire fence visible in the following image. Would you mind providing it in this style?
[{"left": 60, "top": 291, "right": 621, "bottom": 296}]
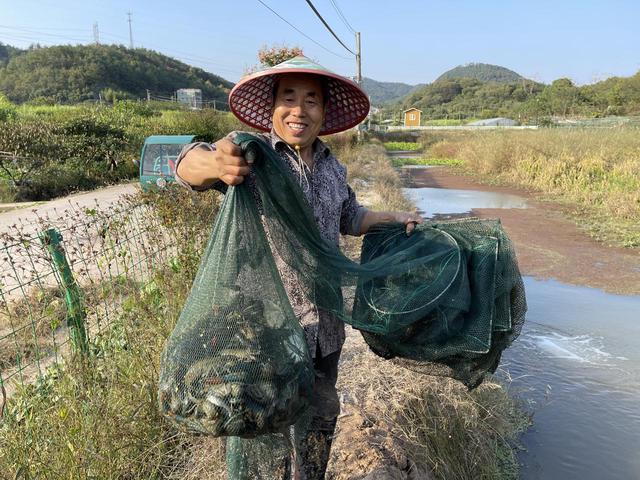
[{"left": 40, "top": 228, "right": 88, "bottom": 354}]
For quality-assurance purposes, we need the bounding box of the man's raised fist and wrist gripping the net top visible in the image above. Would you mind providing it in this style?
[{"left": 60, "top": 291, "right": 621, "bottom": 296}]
[{"left": 178, "top": 138, "right": 251, "bottom": 187}]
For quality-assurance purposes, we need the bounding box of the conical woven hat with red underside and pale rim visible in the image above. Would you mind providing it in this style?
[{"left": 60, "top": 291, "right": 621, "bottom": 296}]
[{"left": 229, "top": 68, "right": 369, "bottom": 135}]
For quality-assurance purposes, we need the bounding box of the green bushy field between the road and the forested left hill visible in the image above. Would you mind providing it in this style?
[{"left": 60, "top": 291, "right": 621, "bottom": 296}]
[{"left": 0, "top": 99, "right": 240, "bottom": 202}]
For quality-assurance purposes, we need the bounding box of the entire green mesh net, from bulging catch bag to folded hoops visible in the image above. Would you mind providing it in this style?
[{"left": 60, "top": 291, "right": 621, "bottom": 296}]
[{"left": 159, "top": 134, "right": 526, "bottom": 478}]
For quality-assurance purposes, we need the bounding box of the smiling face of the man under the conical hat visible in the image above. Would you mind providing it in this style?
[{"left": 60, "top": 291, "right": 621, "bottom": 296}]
[{"left": 272, "top": 74, "right": 325, "bottom": 149}]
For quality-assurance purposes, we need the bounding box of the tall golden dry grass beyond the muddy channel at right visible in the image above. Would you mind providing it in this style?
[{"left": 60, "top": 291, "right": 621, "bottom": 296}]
[{"left": 430, "top": 128, "right": 640, "bottom": 247}]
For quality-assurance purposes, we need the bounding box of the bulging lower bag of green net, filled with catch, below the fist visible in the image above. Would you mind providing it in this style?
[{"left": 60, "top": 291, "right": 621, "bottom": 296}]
[{"left": 159, "top": 155, "right": 314, "bottom": 436}]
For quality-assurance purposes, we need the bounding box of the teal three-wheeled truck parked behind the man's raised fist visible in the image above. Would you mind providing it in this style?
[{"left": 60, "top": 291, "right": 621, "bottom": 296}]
[{"left": 139, "top": 135, "right": 195, "bottom": 191}]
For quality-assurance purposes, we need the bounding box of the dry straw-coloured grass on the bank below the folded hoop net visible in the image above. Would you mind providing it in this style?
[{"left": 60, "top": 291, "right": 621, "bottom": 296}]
[{"left": 331, "top": 330, "right": 529, "bottom": 480}]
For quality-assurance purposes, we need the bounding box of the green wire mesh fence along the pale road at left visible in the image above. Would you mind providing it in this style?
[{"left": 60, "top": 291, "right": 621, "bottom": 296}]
[{"left": 0, "top": 195, "right": 182, "bottom": 402}]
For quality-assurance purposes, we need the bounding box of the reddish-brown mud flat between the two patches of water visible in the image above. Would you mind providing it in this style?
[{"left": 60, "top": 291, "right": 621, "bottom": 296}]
[{"left": 404, "top": 167, "right": 640, "bottom": 295}]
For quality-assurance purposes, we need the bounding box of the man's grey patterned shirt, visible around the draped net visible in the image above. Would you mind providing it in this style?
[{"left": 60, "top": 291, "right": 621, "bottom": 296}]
[{"left": 175, "top": 131, "right": 367, "bottom": 357}]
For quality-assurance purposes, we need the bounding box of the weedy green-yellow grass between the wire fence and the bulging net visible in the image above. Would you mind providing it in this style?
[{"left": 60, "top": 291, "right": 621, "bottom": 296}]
[{"left": 0, "top": 192, "right": 224, "bottom": 479}]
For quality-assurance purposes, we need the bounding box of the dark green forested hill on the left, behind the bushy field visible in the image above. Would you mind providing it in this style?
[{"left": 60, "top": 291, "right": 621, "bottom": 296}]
[{"left": 0, "top": 45, "right": 233, "bottom": 103}]
